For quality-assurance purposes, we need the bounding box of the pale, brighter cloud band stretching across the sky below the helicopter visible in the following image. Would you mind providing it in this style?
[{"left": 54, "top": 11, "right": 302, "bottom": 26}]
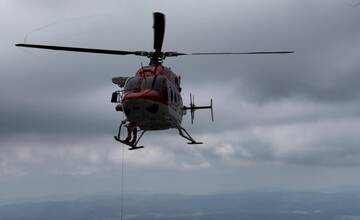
[{"left": 1, "top": 113, "right": 360, "bottom": 179}]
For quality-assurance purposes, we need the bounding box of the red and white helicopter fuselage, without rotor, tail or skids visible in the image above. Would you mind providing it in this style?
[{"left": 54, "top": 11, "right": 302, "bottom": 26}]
[{"left": 121, "top": 64, "right": 185, "bottom": 130}]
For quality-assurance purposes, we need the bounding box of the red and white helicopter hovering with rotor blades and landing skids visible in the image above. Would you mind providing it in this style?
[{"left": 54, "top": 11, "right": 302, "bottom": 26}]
[{"left": 16, "top": 12, "right": 294, "bottom": 150}]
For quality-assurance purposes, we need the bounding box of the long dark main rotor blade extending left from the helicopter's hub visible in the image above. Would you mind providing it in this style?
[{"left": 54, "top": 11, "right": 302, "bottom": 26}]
[{"left": 15, "top": 44, "right": 140, "bottom": 55}]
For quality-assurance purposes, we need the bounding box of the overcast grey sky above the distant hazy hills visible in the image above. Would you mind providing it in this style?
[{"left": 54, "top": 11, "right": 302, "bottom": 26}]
[{"left": 0, "top": 0, "right": 360, "bottom": 198}]
